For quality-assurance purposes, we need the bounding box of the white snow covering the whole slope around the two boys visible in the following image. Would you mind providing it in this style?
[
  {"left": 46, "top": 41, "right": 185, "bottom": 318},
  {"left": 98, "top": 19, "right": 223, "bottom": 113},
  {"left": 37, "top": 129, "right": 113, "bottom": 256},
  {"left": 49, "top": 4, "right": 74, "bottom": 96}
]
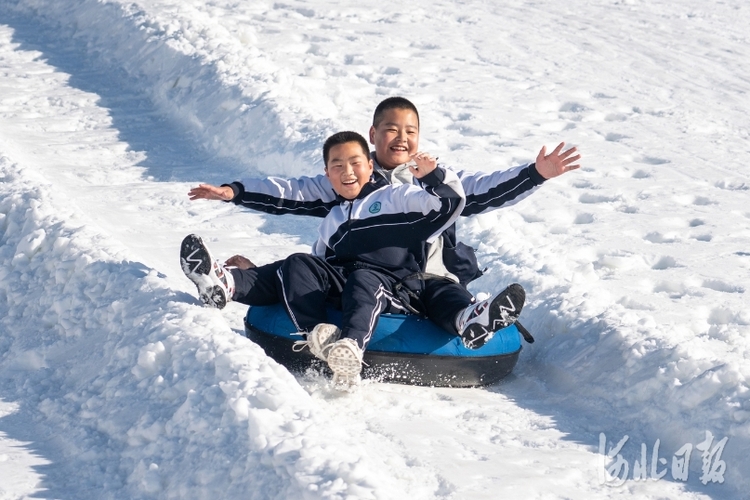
[{"left": 0, "top": 0, "right": 750, "bottom": 499}]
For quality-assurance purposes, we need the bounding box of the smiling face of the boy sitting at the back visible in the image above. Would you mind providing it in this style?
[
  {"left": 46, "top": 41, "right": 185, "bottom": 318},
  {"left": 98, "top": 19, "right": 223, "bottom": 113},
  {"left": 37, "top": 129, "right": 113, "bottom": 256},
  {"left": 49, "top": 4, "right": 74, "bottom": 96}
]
[{"left": 370, "top": 108, "right": 419, "bottom": 170}]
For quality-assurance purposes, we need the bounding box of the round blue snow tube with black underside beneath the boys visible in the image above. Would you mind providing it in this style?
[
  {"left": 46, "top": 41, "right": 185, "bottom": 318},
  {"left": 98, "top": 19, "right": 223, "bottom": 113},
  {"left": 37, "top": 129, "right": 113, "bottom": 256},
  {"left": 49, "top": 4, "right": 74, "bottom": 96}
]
[{"left": 245, "top": 304, "right": 521, "bottom": 387}]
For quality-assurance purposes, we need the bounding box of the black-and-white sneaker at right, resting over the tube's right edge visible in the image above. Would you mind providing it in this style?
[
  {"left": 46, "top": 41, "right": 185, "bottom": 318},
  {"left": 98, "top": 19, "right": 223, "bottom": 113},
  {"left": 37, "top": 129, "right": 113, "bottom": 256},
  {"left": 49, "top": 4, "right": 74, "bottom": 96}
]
[{"left": 456, "top": 283, "right": 526, "bottom": 349}]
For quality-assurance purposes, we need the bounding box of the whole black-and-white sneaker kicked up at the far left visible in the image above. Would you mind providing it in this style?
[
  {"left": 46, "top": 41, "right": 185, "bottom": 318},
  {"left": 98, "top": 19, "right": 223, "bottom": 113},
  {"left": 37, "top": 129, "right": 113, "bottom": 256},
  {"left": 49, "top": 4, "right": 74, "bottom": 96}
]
[{"left": 180, "top": 234, "right": 234, "bottom": 309}]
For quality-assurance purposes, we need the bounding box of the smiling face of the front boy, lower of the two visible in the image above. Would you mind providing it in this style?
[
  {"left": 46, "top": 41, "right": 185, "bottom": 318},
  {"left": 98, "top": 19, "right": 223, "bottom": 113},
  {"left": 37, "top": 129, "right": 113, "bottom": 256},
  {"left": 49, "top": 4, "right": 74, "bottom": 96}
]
[{"left": 326, "top": 141, "right": 372, "bottom": 200}]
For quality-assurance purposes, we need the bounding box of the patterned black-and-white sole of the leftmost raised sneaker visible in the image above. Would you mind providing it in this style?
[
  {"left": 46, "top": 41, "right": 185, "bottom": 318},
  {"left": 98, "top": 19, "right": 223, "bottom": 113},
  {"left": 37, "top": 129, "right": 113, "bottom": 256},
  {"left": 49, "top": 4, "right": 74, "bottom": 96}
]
[{"left": 180, "top": 234, "right": 227, "bottom": 309}]
